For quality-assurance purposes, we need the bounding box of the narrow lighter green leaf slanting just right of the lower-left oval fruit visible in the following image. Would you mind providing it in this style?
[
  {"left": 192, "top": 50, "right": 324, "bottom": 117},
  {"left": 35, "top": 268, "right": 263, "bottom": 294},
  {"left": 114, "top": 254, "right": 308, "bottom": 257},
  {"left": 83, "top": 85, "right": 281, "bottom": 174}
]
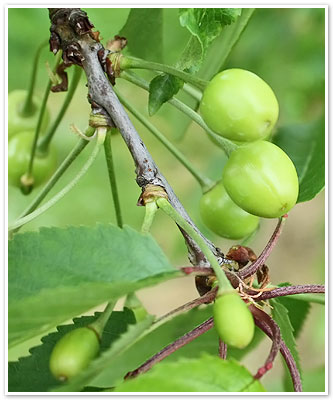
[{"left": 54, "top": 315, "right": 154, "bottom": 392}]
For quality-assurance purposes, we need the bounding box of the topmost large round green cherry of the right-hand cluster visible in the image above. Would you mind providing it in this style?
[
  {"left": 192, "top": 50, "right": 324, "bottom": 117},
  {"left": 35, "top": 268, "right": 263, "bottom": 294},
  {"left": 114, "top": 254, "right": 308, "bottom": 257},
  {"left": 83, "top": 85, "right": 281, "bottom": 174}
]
[{"left": 200, "top": 68, "right": 279, "bottom": 142}]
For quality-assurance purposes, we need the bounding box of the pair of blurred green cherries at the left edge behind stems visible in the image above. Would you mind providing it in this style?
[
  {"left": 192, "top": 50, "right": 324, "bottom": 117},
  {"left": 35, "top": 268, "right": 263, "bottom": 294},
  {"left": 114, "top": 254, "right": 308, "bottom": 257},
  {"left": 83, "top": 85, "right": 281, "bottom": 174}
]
[{"left": 8, "top": 90, "right": 57, "bottom": 192}]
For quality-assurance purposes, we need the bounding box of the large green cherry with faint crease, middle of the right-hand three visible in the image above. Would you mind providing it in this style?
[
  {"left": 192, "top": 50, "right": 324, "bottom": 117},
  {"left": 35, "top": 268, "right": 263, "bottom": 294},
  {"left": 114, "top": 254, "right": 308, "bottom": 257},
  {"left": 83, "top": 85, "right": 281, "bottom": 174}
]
[{"left": 223, "top": 141, "right": 299, "bottom": 218}]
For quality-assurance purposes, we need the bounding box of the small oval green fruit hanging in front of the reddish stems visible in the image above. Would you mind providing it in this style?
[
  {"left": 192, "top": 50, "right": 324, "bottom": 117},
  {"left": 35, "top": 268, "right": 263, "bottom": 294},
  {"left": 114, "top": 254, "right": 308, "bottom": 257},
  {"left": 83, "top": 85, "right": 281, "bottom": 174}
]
[{"left": 213, "top": 291, "right": 254, "bottom": 349}]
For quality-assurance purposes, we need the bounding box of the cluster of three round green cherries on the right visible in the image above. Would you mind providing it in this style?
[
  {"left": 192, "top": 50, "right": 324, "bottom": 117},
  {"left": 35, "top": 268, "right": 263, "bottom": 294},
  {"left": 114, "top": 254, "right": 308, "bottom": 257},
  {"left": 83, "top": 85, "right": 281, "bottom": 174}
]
[{"left": 200, "top": 69, "right": 299, "bottom": 239}]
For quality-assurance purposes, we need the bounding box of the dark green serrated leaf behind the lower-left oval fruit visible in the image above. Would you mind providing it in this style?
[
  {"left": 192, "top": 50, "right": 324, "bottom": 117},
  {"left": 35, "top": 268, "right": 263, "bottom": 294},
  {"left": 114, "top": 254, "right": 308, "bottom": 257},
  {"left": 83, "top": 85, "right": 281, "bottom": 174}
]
[{"left": 8, "top": 309, "right": 135, "bottom": 392}]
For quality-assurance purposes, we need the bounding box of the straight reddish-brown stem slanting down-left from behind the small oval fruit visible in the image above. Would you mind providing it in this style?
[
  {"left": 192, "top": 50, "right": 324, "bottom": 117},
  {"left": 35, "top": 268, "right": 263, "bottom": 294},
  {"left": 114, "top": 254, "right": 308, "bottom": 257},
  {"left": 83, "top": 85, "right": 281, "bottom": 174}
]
[{"left": 124, "top": 318, "right": 214, "bottom": 379}]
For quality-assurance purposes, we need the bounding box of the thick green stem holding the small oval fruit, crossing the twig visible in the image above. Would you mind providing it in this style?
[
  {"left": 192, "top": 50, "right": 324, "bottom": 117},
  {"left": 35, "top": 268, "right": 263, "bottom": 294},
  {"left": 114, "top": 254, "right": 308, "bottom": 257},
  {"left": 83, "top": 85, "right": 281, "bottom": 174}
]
[{"left": 156, "top": 198, "right": 234, "bottom": 295}]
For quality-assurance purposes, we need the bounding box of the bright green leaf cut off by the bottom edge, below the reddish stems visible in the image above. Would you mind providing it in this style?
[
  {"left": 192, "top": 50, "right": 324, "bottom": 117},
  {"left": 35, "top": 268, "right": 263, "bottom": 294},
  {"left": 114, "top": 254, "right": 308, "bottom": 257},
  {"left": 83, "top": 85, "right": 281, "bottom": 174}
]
[{"left": 115, "top": 355, "right": 265, "bottom": 392}]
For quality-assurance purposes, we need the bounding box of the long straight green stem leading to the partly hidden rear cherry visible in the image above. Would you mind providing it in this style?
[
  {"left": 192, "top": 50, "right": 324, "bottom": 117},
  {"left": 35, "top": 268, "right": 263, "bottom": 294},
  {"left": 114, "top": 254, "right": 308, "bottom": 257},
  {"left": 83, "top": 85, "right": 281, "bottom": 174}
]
[{"left": 116, "top": 92, "right": 215, "bottom": 193}]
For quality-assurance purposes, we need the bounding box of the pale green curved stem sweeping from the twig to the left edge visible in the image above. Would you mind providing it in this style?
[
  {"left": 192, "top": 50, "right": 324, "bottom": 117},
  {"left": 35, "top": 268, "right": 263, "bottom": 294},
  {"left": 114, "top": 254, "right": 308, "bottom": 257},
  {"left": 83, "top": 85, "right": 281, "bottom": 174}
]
[{"left": 9, "top": 128, "right": 106, "bottom": 231}]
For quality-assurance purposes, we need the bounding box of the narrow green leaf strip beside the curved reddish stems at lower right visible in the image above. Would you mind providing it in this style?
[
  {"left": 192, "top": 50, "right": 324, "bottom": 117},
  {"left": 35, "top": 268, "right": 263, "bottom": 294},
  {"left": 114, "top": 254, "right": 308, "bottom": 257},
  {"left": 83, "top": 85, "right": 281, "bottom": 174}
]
[{"left": 270, "top": 299, "right": 302, "bottom": 376}]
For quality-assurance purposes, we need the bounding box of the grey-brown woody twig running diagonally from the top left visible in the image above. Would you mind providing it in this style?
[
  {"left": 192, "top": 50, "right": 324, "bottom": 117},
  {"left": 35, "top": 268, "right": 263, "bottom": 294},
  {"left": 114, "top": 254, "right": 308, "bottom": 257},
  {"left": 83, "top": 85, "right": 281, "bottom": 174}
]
[{"left": 49, "top": 8, "right": 223, "bottom": 266}]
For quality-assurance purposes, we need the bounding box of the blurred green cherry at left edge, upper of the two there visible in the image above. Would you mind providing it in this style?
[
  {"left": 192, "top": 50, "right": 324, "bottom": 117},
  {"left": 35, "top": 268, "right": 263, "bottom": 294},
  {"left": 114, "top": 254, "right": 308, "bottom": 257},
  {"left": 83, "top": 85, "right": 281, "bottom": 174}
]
[{"left": 8, "top": 90, "right": 50, "bottom": 139}]
